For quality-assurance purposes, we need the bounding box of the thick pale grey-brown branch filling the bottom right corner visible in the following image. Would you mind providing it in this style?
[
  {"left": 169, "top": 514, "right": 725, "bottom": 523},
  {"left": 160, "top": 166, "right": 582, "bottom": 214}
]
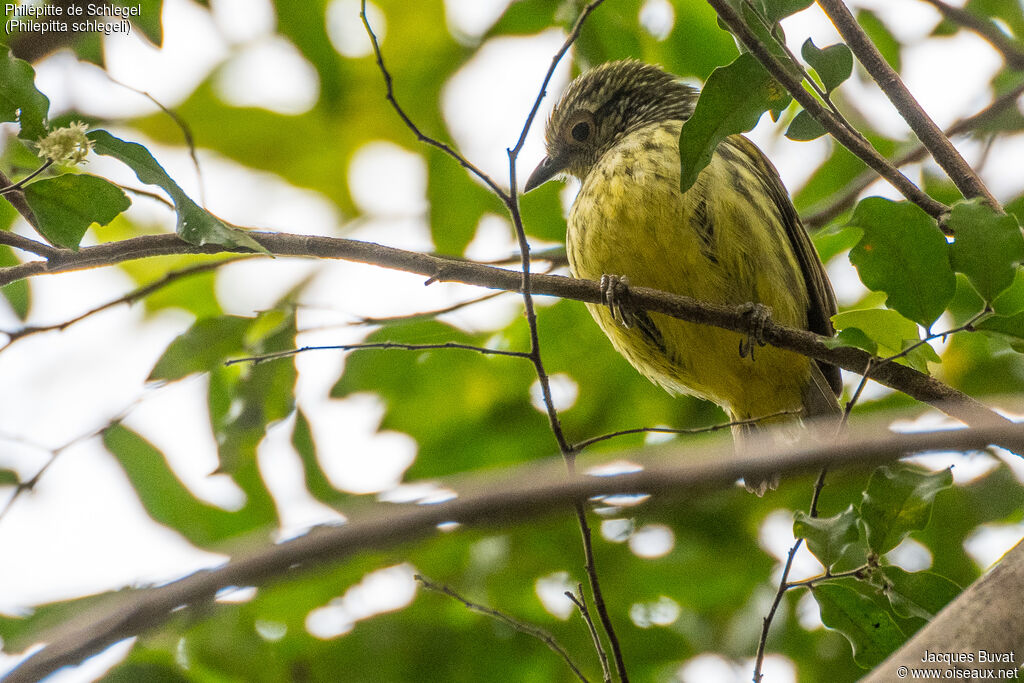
[{"left": 863, "top": 543, "right": 1024, "bottom": 683}]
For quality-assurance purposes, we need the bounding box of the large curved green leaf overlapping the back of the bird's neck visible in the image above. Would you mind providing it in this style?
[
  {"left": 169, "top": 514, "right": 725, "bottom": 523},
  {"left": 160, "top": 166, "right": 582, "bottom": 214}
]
[{"left": 679, "top": 53, "right": 791, "bottom": 191}]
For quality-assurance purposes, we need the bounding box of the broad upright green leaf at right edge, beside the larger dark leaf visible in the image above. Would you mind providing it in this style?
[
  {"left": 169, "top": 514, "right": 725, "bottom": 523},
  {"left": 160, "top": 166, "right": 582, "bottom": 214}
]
[{"left": 946, "top": 200, "right": 1024, "bottom": 302}]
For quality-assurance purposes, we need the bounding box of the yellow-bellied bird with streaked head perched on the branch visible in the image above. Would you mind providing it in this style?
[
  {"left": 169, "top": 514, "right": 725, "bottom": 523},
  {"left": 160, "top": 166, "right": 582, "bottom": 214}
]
[{"left": 523, "top": 59, "right": 843, "bottom": 495}]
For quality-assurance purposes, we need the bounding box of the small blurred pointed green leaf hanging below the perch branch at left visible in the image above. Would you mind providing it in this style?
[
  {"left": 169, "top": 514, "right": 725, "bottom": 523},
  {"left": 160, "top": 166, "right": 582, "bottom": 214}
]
[{"left": 147, "top": 315, "right": 255, "bottom": 382}]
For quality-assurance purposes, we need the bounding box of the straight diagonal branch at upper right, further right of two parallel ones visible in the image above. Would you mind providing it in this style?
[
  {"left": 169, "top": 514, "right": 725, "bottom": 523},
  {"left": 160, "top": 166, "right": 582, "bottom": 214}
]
[{"left": 817, "top": 0, "right": 1002, "bottom": 211}]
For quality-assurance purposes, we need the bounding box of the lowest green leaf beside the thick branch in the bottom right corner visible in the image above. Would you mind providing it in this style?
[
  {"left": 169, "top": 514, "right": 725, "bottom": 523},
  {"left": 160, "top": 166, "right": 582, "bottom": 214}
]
[{"left": 811, "top": 584, "right": 906, "bottom": 669}]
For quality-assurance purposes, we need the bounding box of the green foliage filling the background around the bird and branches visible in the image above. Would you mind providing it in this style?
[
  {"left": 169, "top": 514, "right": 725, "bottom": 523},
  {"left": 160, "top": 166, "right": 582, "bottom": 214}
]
[{"left": 0, "top": 0, "right": 1024, "bottom": 682}]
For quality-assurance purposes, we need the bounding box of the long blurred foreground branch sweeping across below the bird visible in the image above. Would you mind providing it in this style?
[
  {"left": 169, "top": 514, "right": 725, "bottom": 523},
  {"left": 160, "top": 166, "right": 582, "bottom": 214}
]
[{"left": 4, "top": 423, "right": 1024, "bottom": 683}]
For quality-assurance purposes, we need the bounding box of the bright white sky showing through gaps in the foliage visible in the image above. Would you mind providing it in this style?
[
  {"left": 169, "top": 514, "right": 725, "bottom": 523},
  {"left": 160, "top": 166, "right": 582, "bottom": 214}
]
[{"left": 0, "top": 0, "right": 1024, "bottom": 683}]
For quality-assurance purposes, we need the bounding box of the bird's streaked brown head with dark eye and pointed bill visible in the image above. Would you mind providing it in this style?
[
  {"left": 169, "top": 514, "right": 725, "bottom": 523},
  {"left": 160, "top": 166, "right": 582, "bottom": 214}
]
[{"left": 523, "top": 59, "right": 697, "bottom": 193}]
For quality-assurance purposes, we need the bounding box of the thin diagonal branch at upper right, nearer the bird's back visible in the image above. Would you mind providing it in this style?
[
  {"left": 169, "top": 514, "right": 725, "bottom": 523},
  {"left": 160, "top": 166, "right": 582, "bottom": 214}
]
[{"left": 708, "top": 0, "right": 948, "bottom": 219}]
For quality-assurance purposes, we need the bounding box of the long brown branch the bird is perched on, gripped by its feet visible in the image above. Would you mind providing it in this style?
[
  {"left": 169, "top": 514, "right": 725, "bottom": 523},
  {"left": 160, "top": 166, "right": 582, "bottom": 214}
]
[{"left": 0, "top": 232, "right": 1007, "bottom": 438}]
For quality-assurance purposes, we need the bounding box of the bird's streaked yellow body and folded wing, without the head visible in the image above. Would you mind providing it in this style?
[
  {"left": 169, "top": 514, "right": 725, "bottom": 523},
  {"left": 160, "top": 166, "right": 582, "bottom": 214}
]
[{"left": 566, "top": 122, "right": 810, "bottom": 419}]
